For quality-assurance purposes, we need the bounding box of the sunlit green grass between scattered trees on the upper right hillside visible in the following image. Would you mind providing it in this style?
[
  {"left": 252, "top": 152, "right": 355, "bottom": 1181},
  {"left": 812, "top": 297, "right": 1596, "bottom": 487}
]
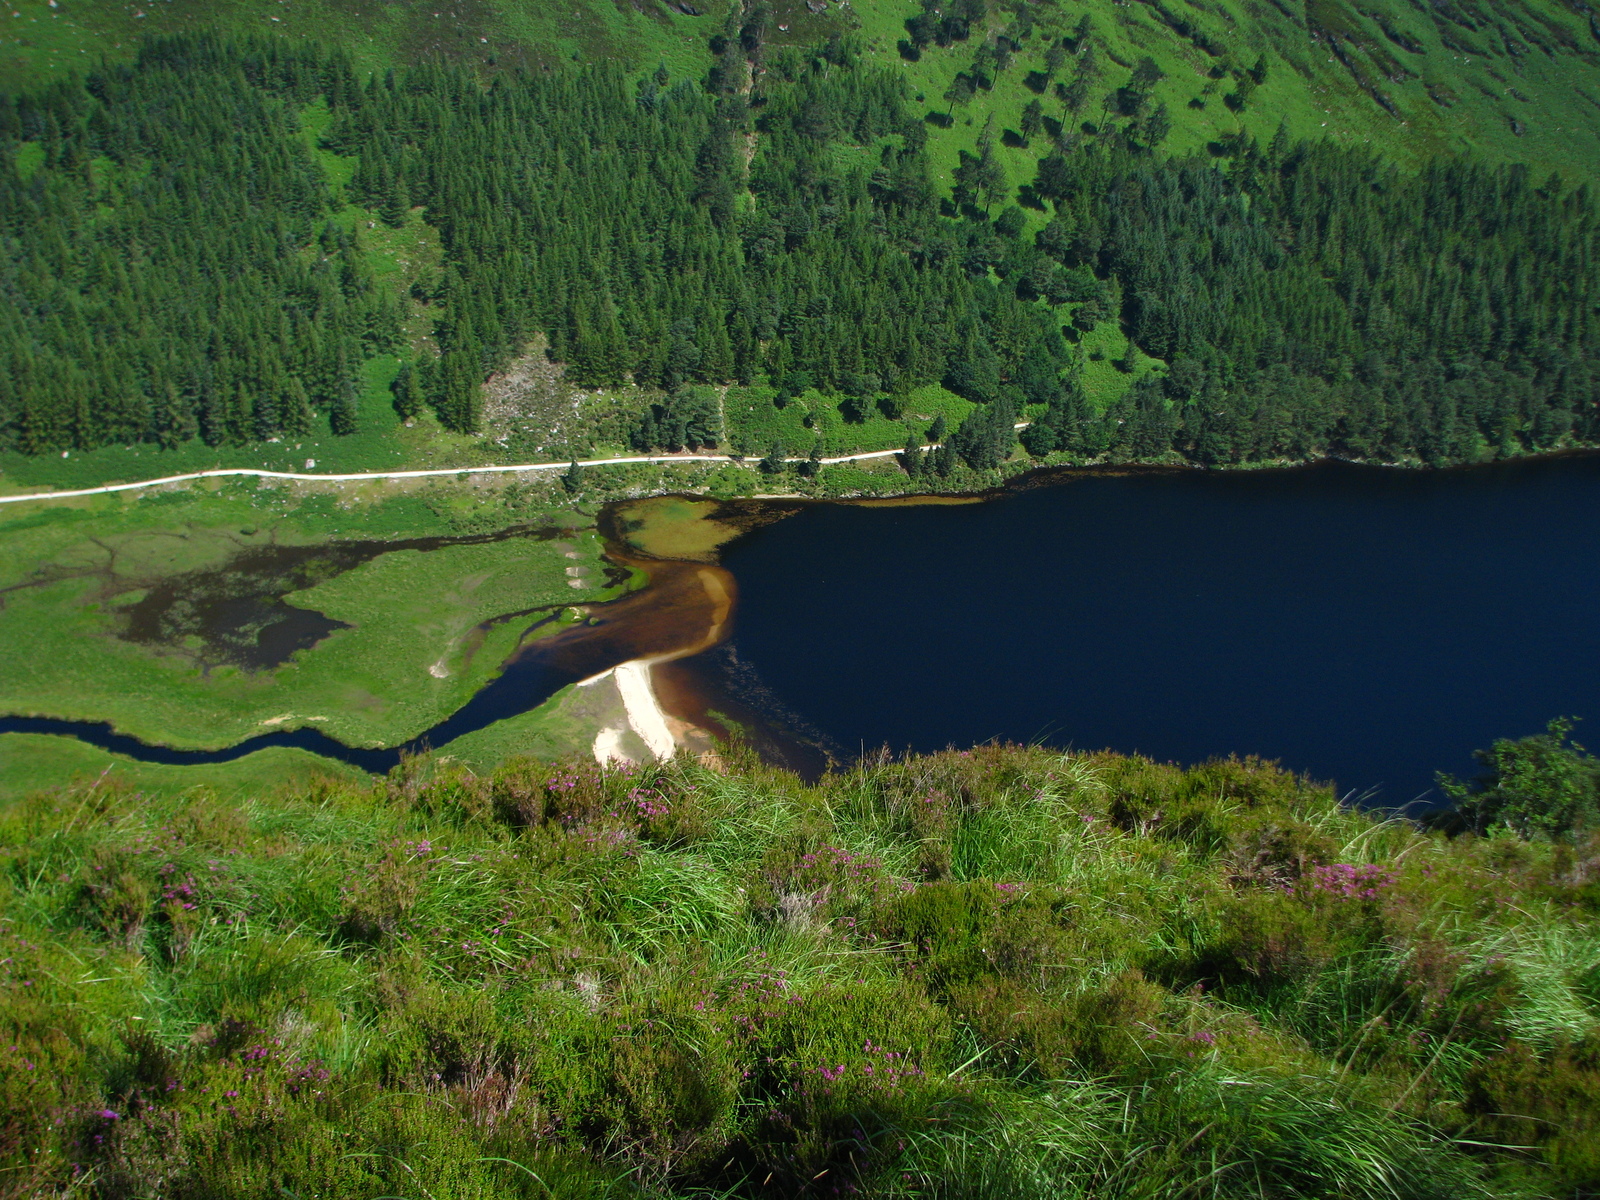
[{"left": 851, "top": 0, "right": 1600, "bottom": 236}]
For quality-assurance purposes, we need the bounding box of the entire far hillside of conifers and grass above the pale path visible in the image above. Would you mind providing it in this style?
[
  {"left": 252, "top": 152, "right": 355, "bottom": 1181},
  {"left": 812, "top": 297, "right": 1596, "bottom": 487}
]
[{"left": 9, "top": 0, "right": 1600, "bottom": 491}]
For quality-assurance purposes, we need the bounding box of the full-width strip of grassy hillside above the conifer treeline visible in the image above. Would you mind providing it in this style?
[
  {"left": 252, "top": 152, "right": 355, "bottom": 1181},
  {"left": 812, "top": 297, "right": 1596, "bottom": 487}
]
[{"left": 0, "top": 0, "right": 1600, "bottom": 184}]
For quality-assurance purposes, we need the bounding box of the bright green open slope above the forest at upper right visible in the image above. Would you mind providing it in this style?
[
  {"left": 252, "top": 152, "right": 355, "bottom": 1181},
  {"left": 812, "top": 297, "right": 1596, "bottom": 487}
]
[{"left": 853, "top": 0, "right": 1600, "bottom": 224}]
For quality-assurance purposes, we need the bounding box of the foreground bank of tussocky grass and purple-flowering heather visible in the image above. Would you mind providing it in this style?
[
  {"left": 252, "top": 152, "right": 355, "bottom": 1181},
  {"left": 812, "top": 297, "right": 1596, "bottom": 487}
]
[{"left": 0, "top": 747, "right": 1600, "bottom": 1200}]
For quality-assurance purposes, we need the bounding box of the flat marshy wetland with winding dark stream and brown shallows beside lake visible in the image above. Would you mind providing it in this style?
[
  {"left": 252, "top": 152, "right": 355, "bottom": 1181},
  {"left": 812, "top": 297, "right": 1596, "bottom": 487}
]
[{"left": 0, "top": 486, "right": 761, "bottom": 781}]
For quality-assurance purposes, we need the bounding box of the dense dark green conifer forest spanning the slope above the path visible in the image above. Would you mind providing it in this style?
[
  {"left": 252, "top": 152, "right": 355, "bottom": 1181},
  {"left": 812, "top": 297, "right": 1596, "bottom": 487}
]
[{"left": 0, "top": 16, "right": 1600, "bottom": 469}]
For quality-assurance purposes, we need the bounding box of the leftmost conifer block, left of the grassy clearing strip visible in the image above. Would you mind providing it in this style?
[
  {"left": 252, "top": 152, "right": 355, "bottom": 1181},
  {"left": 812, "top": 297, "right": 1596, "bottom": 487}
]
[{"left": 0, "top": 43, "right": 400, "bottom": 453}]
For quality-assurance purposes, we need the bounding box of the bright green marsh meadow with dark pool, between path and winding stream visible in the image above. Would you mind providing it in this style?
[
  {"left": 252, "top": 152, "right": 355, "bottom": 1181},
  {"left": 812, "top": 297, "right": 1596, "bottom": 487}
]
[{"left": 0, "top": 486, "right": 616, "bottom": 747}]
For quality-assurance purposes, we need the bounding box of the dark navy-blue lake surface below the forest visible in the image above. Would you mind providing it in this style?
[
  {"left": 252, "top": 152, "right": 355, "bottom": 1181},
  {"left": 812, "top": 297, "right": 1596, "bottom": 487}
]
[{"left": 710, "top": 456, "right": 1600, "bottom": 805}]
